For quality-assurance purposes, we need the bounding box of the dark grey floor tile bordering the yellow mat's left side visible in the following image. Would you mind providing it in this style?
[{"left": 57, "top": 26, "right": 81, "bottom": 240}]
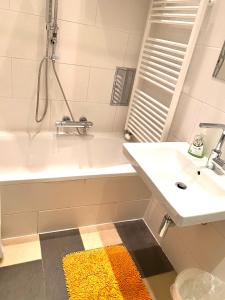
[{"left": 40, "top": 229, "right": 84, "bottom": 300}]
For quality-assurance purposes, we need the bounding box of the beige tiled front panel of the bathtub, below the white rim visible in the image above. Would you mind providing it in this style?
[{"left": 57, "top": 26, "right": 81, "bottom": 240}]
[{"left": 1, "top": 175, "right": 151, "bottom": 238}]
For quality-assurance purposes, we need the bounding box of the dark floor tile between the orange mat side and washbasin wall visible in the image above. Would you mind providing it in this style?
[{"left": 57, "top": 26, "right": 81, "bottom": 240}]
[{"left": 115, "top": 220, "right": 173, "bottom": 277}]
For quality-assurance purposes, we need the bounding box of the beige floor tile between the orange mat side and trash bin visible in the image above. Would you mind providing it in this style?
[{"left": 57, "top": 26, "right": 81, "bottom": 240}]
[{"left": 144, "top": 271, "right": 177, "bottom": 300}]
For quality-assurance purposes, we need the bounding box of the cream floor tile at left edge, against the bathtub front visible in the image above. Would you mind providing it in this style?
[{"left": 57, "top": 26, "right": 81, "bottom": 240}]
[{"left": 0, "top": 235, "right": 41, "bottom": 268}]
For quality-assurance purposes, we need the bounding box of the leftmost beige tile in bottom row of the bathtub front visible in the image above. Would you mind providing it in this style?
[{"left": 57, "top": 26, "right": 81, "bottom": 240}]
[{"left": 2, "top": 212, "right": 37, "bottom": 239}]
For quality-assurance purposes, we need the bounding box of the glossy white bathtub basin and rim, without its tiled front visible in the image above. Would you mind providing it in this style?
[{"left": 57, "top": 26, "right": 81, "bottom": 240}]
[{"left": 0, "top": 132, "right": 135, "bottom": 184}]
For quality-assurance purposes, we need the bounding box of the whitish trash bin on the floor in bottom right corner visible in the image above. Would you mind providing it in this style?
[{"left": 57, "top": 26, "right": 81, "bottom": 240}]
[{"left": 171, "top": 269, "right": 225, "bottom": 300}]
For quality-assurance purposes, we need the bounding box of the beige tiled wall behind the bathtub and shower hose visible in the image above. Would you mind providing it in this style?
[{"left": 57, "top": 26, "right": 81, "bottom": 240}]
[{"left": 0, "top": 0, "right": 149, "bottom": 131}]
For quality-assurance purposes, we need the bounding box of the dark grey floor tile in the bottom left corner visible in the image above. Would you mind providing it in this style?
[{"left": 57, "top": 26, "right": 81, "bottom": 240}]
[{"left": 0, "top": 260, "right": 46, "bottom": 300}]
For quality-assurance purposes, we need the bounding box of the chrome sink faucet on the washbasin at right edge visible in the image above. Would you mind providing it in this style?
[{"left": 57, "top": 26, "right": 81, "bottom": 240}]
[{"left": 199, "top": 123, "right": 225, "bottom": 174}]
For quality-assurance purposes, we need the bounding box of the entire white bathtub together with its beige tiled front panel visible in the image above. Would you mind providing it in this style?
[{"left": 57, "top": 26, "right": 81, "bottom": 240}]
[{"left": 0, "top": 132, "right": 150, "bottom": 238}]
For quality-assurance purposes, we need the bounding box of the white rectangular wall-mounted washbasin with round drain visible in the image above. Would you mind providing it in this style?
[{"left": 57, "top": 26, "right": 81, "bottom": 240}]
[{"left": 124, "top": 143, "right": 225, "bottom": 226}]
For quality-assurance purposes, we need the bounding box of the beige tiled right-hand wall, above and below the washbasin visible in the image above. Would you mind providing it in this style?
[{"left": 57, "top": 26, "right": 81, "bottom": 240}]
[{"left": 146, "top": 0, "right": 225, "bottom": 280}]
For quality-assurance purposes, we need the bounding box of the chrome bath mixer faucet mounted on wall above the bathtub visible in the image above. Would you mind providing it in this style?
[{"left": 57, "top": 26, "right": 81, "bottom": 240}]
[{"left": 55, "top": 116, "right": 94, "bottom": 135}]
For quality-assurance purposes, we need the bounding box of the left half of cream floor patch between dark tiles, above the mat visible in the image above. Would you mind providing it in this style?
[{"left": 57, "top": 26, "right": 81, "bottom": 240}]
[{"left": 79, "top": 226, "right": 104, "bottom": 250}]
